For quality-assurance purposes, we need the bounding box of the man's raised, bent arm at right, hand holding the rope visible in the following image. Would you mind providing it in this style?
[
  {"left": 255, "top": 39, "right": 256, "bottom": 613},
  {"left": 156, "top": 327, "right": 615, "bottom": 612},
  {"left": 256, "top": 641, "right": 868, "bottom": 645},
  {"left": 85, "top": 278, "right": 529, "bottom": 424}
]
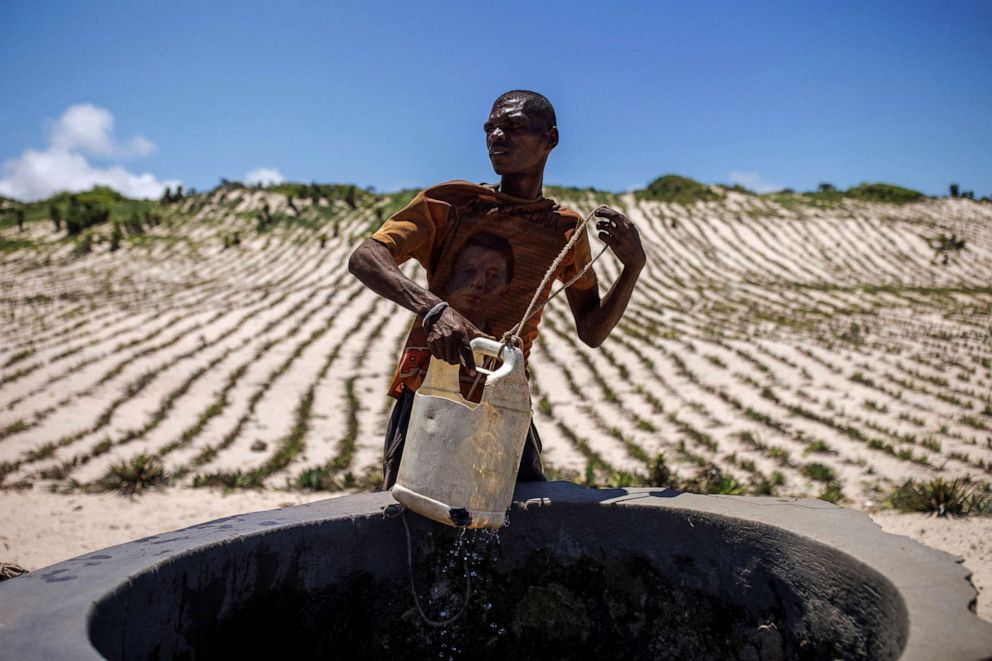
[{"left": 565, "top": 207, "right": 647, "bottom": 347}]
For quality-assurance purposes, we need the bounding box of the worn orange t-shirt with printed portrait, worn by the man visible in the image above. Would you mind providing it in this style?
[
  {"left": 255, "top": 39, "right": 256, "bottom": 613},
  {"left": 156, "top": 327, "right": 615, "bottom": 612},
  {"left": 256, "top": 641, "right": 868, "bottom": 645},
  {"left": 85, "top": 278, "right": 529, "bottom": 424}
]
[{"left": 372, "top": 181, "right": 596, "bottom": 396}]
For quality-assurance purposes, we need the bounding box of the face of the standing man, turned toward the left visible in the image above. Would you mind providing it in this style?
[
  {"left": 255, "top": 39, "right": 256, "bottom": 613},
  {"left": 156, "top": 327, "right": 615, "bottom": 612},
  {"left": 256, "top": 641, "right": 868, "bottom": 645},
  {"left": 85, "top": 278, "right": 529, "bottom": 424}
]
[{"left": 483, "top": 97, "right": 558, "bottom": 176}]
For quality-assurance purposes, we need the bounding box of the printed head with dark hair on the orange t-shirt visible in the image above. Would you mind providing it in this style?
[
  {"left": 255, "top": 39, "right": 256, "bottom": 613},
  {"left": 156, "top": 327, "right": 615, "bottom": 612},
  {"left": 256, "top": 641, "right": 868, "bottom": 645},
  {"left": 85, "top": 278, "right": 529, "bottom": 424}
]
[{"left": 446, "top": 232, "right": 514, "bottom": 326}]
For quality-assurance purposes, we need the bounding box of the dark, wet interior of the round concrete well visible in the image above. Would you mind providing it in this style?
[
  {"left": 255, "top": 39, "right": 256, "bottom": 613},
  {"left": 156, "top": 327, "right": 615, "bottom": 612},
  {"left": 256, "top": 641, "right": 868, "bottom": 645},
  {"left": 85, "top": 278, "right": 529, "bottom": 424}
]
[{"left": 90, "top": 504, "right": 907, "bottom": 659}]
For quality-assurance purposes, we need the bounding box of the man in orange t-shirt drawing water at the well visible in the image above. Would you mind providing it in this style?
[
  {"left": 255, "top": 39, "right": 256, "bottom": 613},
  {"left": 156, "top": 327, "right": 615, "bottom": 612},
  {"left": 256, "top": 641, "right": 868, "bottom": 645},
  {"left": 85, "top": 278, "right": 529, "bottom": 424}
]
[{"left": 349, "top": 90, "right": 645, "bottom": 489}]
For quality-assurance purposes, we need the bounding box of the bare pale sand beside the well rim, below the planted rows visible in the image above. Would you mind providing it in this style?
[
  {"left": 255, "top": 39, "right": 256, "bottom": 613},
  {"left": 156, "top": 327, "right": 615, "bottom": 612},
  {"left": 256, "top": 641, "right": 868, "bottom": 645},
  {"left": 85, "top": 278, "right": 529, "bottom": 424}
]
[{"left": 0, "top": 487, "right": 992, "bottom": 621}]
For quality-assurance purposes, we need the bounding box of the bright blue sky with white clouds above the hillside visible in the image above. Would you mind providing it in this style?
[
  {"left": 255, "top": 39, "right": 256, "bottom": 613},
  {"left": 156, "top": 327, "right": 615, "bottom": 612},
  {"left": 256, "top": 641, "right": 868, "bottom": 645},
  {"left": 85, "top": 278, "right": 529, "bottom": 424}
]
[{"left": 0, "top": 0, "right": 992, "bottom": 198}]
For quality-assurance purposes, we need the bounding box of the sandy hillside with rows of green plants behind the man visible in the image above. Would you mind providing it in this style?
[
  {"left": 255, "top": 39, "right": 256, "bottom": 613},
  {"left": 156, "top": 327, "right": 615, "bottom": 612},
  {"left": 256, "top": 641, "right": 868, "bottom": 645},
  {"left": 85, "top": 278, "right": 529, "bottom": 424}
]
[{"left": 0, "top": 182, "right": 992, "bottom": 509}]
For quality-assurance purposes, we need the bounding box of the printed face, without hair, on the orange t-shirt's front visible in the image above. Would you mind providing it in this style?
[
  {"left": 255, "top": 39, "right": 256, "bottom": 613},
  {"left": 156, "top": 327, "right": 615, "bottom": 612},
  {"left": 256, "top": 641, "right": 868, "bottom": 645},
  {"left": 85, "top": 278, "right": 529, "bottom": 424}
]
[{"left": 447, "top": 246, "right": 507, "bottom": 325}]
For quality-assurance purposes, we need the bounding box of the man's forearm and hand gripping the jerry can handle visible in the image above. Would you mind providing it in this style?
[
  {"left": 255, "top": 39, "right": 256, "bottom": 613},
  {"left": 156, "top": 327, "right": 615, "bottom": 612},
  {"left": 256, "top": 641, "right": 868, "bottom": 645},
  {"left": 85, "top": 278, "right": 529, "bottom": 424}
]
[{"left": 348, "top": 238, "right": 485, "bottom": 374}]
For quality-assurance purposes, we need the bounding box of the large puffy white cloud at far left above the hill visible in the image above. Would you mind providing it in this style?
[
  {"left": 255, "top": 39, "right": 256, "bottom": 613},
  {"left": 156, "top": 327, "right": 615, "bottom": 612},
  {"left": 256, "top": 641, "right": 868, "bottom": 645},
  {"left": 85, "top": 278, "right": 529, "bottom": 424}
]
[{"left": 0, "top": 104, "right": 175, "bottom": 201}]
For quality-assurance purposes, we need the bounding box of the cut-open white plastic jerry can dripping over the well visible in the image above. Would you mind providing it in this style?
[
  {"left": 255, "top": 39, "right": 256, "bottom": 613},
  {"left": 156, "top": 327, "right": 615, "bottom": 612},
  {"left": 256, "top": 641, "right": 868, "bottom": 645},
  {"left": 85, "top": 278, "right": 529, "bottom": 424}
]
[{"left": 393, "top": 337, "right": 531, "bottom": 528}]
